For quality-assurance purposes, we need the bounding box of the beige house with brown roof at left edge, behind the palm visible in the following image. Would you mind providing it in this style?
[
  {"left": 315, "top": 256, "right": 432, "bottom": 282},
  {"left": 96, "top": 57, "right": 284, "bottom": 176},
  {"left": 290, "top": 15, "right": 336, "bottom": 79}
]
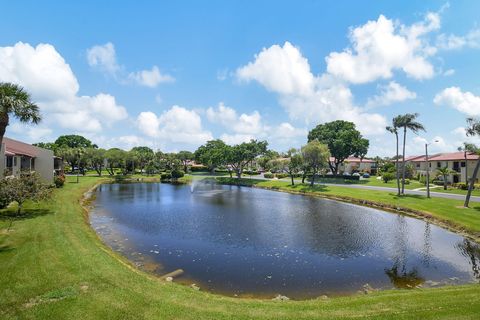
[{"left": 0, "top": 137, "right": 59, "bottom": 183}]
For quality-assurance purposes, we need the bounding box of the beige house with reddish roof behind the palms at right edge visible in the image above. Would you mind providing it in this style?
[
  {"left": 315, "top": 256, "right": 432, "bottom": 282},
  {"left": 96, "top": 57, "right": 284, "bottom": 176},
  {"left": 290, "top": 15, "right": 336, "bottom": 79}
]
[{"left": 405, "top": 151, "right": 479, "bottom": 183}]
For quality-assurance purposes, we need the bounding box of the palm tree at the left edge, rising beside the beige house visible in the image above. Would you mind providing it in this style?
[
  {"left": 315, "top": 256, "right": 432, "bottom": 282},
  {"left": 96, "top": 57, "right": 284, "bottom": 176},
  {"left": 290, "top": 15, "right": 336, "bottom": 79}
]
[{"left": 0, "top": 82, "right": 41, "bottom": 146}]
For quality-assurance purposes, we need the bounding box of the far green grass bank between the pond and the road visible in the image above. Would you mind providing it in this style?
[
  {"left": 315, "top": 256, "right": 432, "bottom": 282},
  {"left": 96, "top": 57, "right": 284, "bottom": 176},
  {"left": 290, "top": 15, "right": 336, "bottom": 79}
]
[{"left": 217, "top": 178, "right": 480, "bottom": 240}]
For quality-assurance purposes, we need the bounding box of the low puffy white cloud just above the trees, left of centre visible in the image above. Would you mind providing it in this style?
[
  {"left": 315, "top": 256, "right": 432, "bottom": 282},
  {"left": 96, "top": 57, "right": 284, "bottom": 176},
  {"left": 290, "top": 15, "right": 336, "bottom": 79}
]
[{"left": 137, "top": 106, "right": 212, "bottom": 145}]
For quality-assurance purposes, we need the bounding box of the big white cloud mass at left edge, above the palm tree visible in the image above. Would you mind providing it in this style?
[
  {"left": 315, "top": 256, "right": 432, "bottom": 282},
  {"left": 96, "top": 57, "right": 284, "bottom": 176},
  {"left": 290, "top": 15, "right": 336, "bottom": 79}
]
[{"left": 0, "top": 42, "right": 128, "bottom": 132}]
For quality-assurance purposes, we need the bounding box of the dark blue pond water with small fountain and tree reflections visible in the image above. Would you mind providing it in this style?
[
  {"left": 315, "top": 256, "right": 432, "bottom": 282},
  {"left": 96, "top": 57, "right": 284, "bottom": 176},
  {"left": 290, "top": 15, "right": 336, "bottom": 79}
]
[{"left": 90, "top": 183, "right": 480, "bottom": 299}]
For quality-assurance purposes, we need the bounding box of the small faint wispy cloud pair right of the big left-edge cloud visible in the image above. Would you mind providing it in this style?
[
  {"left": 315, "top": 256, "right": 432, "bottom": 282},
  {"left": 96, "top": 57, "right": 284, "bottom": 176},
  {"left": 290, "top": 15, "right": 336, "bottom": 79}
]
[{"left": 87, "top": 42, "right": 175, "bottom": 88}]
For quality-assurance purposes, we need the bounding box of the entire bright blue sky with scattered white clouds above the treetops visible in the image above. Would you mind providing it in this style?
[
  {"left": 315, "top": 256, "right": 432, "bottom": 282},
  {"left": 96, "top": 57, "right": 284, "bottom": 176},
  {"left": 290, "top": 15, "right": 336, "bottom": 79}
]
[{"left": 0, "top": 1, "right": 480, "bottom": 156}]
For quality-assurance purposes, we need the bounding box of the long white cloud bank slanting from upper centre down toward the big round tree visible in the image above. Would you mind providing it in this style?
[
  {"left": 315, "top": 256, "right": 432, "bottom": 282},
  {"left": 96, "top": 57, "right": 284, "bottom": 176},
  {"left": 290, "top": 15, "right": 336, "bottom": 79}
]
[{"left": 236, "top": 42, "right": 386, "bottom": 134}]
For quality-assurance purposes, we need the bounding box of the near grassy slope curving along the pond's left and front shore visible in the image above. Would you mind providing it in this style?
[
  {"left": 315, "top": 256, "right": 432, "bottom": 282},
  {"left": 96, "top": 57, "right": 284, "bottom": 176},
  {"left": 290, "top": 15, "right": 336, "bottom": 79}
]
[{"left": 0, "top": 177, "right": 480, "bottom": 320}]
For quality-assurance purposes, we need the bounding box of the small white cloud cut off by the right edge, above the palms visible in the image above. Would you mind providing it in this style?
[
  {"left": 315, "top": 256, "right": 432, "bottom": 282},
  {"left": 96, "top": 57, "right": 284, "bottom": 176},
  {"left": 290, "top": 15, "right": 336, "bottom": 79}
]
[{"left": 433, "top": 87, "right": 480, "bottom": 117}]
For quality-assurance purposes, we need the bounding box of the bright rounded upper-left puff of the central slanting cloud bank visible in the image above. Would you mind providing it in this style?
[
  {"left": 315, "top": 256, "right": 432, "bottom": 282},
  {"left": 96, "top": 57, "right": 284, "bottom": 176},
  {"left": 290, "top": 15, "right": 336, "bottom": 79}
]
[{"left": 236, "top": 41, "right": 314, "bottom": 94}]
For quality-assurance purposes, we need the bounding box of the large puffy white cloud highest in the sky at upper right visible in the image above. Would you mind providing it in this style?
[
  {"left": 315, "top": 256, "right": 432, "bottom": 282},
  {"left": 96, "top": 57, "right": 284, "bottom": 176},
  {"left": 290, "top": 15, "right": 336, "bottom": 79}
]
[{"left": 326, "top": 13, "right": 440, "bottom": 84}]
